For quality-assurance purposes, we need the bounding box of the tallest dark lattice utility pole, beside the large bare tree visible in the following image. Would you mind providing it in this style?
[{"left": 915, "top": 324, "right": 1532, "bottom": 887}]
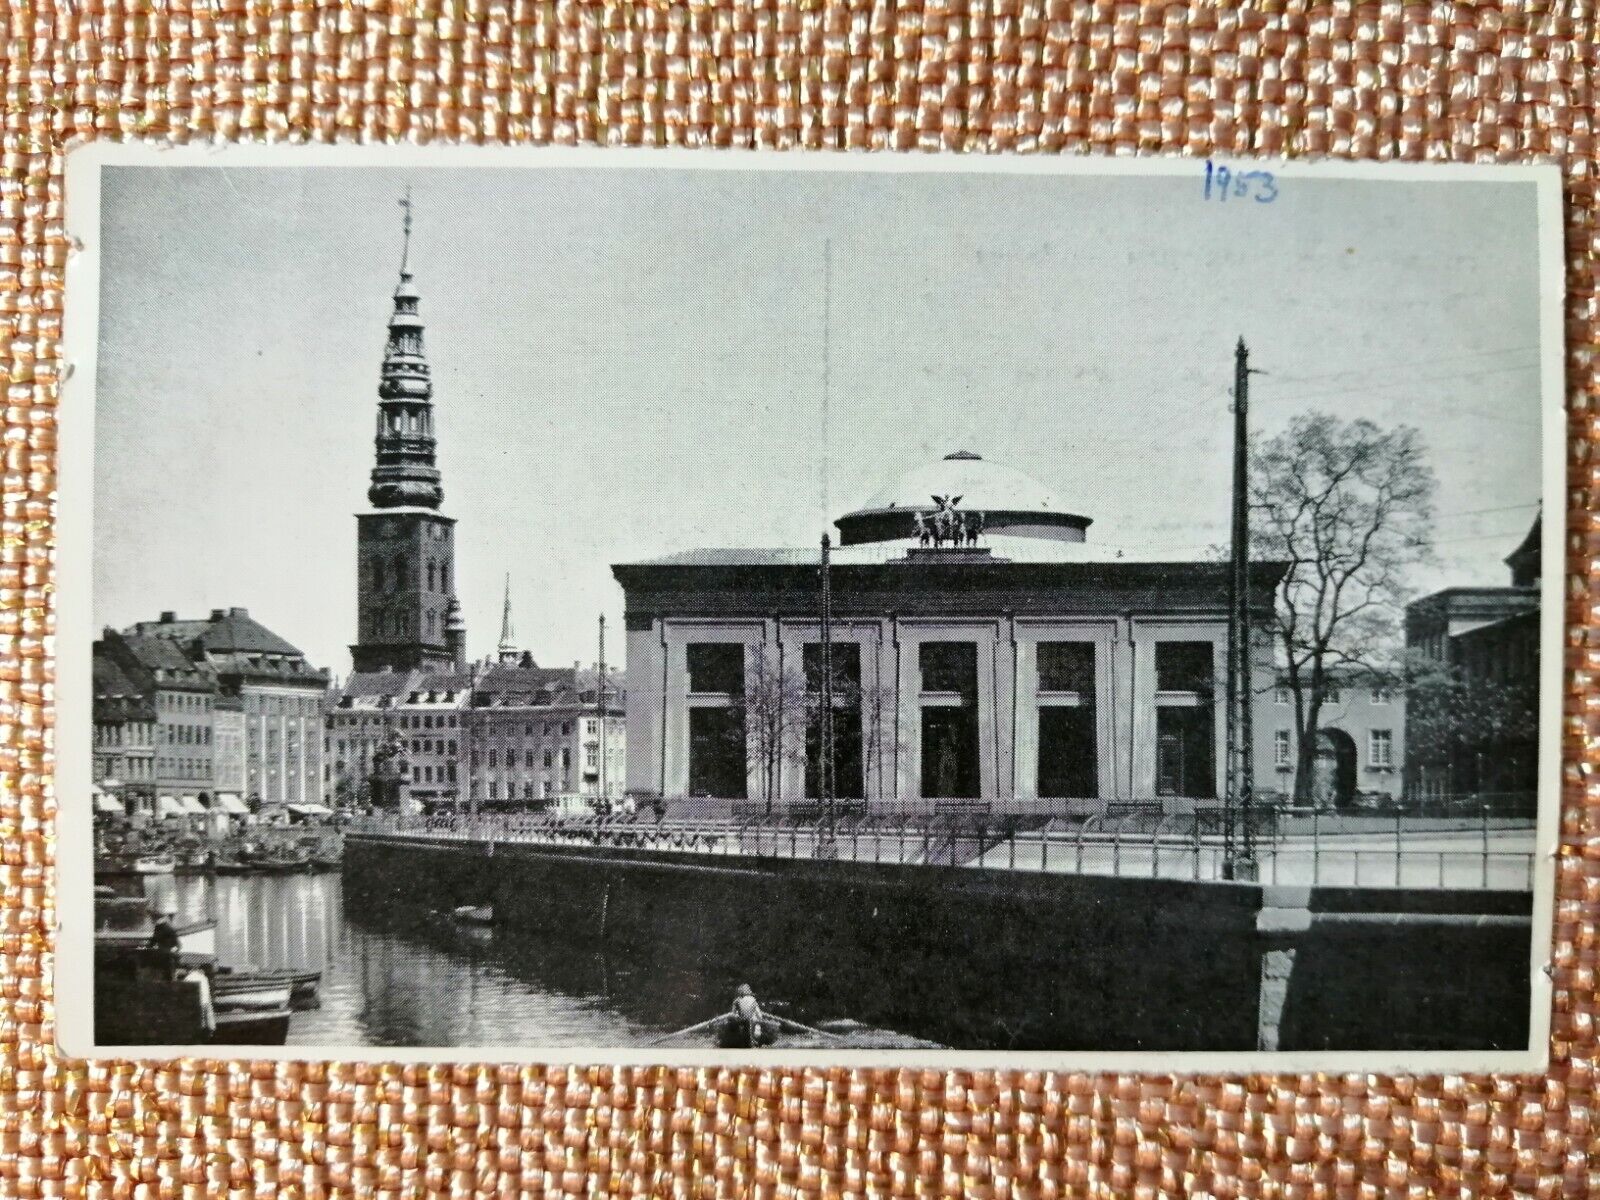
[{"left": 1222, "top": 338, "right": 1256, "bottom": 880}]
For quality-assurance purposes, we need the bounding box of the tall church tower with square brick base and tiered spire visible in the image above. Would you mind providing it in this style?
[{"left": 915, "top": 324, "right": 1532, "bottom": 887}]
[{"left": 350, "top": 192, "right": 466, "bottom": 670}]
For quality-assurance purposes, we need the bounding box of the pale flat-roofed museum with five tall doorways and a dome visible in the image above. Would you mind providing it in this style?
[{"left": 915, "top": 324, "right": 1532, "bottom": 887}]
[{"left": 613, "top": 453, "right": 1285, "bottom": 813}]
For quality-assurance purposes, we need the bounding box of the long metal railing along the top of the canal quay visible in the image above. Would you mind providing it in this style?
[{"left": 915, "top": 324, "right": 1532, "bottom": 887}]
[{"left": 350, "top": 806, "right": 1534, "bottom": 891}]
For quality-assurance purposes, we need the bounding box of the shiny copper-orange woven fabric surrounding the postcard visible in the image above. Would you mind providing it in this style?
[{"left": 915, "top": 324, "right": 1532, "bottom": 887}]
[{"left": 0, "top": 0, "right": 1600, "bottom": 1198}]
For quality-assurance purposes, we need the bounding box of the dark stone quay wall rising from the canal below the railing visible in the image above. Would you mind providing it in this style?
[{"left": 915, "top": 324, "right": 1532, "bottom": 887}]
[{"left": 344, "top": 834, "right": 1531, "bottom": 1051}]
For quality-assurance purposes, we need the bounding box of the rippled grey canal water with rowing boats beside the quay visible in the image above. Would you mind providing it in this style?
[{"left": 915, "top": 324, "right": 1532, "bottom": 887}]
[{"left": 118, "top": 874, "right": 915, "bottom": 1050}]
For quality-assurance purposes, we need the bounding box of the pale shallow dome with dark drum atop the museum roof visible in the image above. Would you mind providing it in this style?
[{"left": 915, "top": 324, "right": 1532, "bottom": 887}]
[{"left": 834, "top": 450, "right": 1090, "bottom": 546}]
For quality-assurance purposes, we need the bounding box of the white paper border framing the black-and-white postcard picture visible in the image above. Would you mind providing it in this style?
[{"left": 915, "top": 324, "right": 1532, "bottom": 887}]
[{"left": 50, "top": 142, "right": 1568, "bottom": 1075}]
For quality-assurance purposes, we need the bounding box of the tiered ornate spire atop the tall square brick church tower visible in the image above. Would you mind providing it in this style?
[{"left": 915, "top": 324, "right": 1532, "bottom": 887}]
[{"left": 366, "top": 189, "right": 445, "bottom": 509}]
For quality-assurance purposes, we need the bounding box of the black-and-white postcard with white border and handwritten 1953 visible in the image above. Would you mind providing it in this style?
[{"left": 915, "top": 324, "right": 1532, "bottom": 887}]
[{"left": 56, "top": 146, "right": 1565, "bottom": 1072}]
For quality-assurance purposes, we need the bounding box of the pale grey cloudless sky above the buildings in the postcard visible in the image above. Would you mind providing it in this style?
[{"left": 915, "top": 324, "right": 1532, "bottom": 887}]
[{"left": 94, "top": 163, "right": 1541, "bottom": 674}]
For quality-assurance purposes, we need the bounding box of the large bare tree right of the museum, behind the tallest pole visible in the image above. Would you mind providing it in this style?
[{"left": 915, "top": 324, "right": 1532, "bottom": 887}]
[{"left": 1250, "top": 413, "right": 1435, "bottom": 803}]
